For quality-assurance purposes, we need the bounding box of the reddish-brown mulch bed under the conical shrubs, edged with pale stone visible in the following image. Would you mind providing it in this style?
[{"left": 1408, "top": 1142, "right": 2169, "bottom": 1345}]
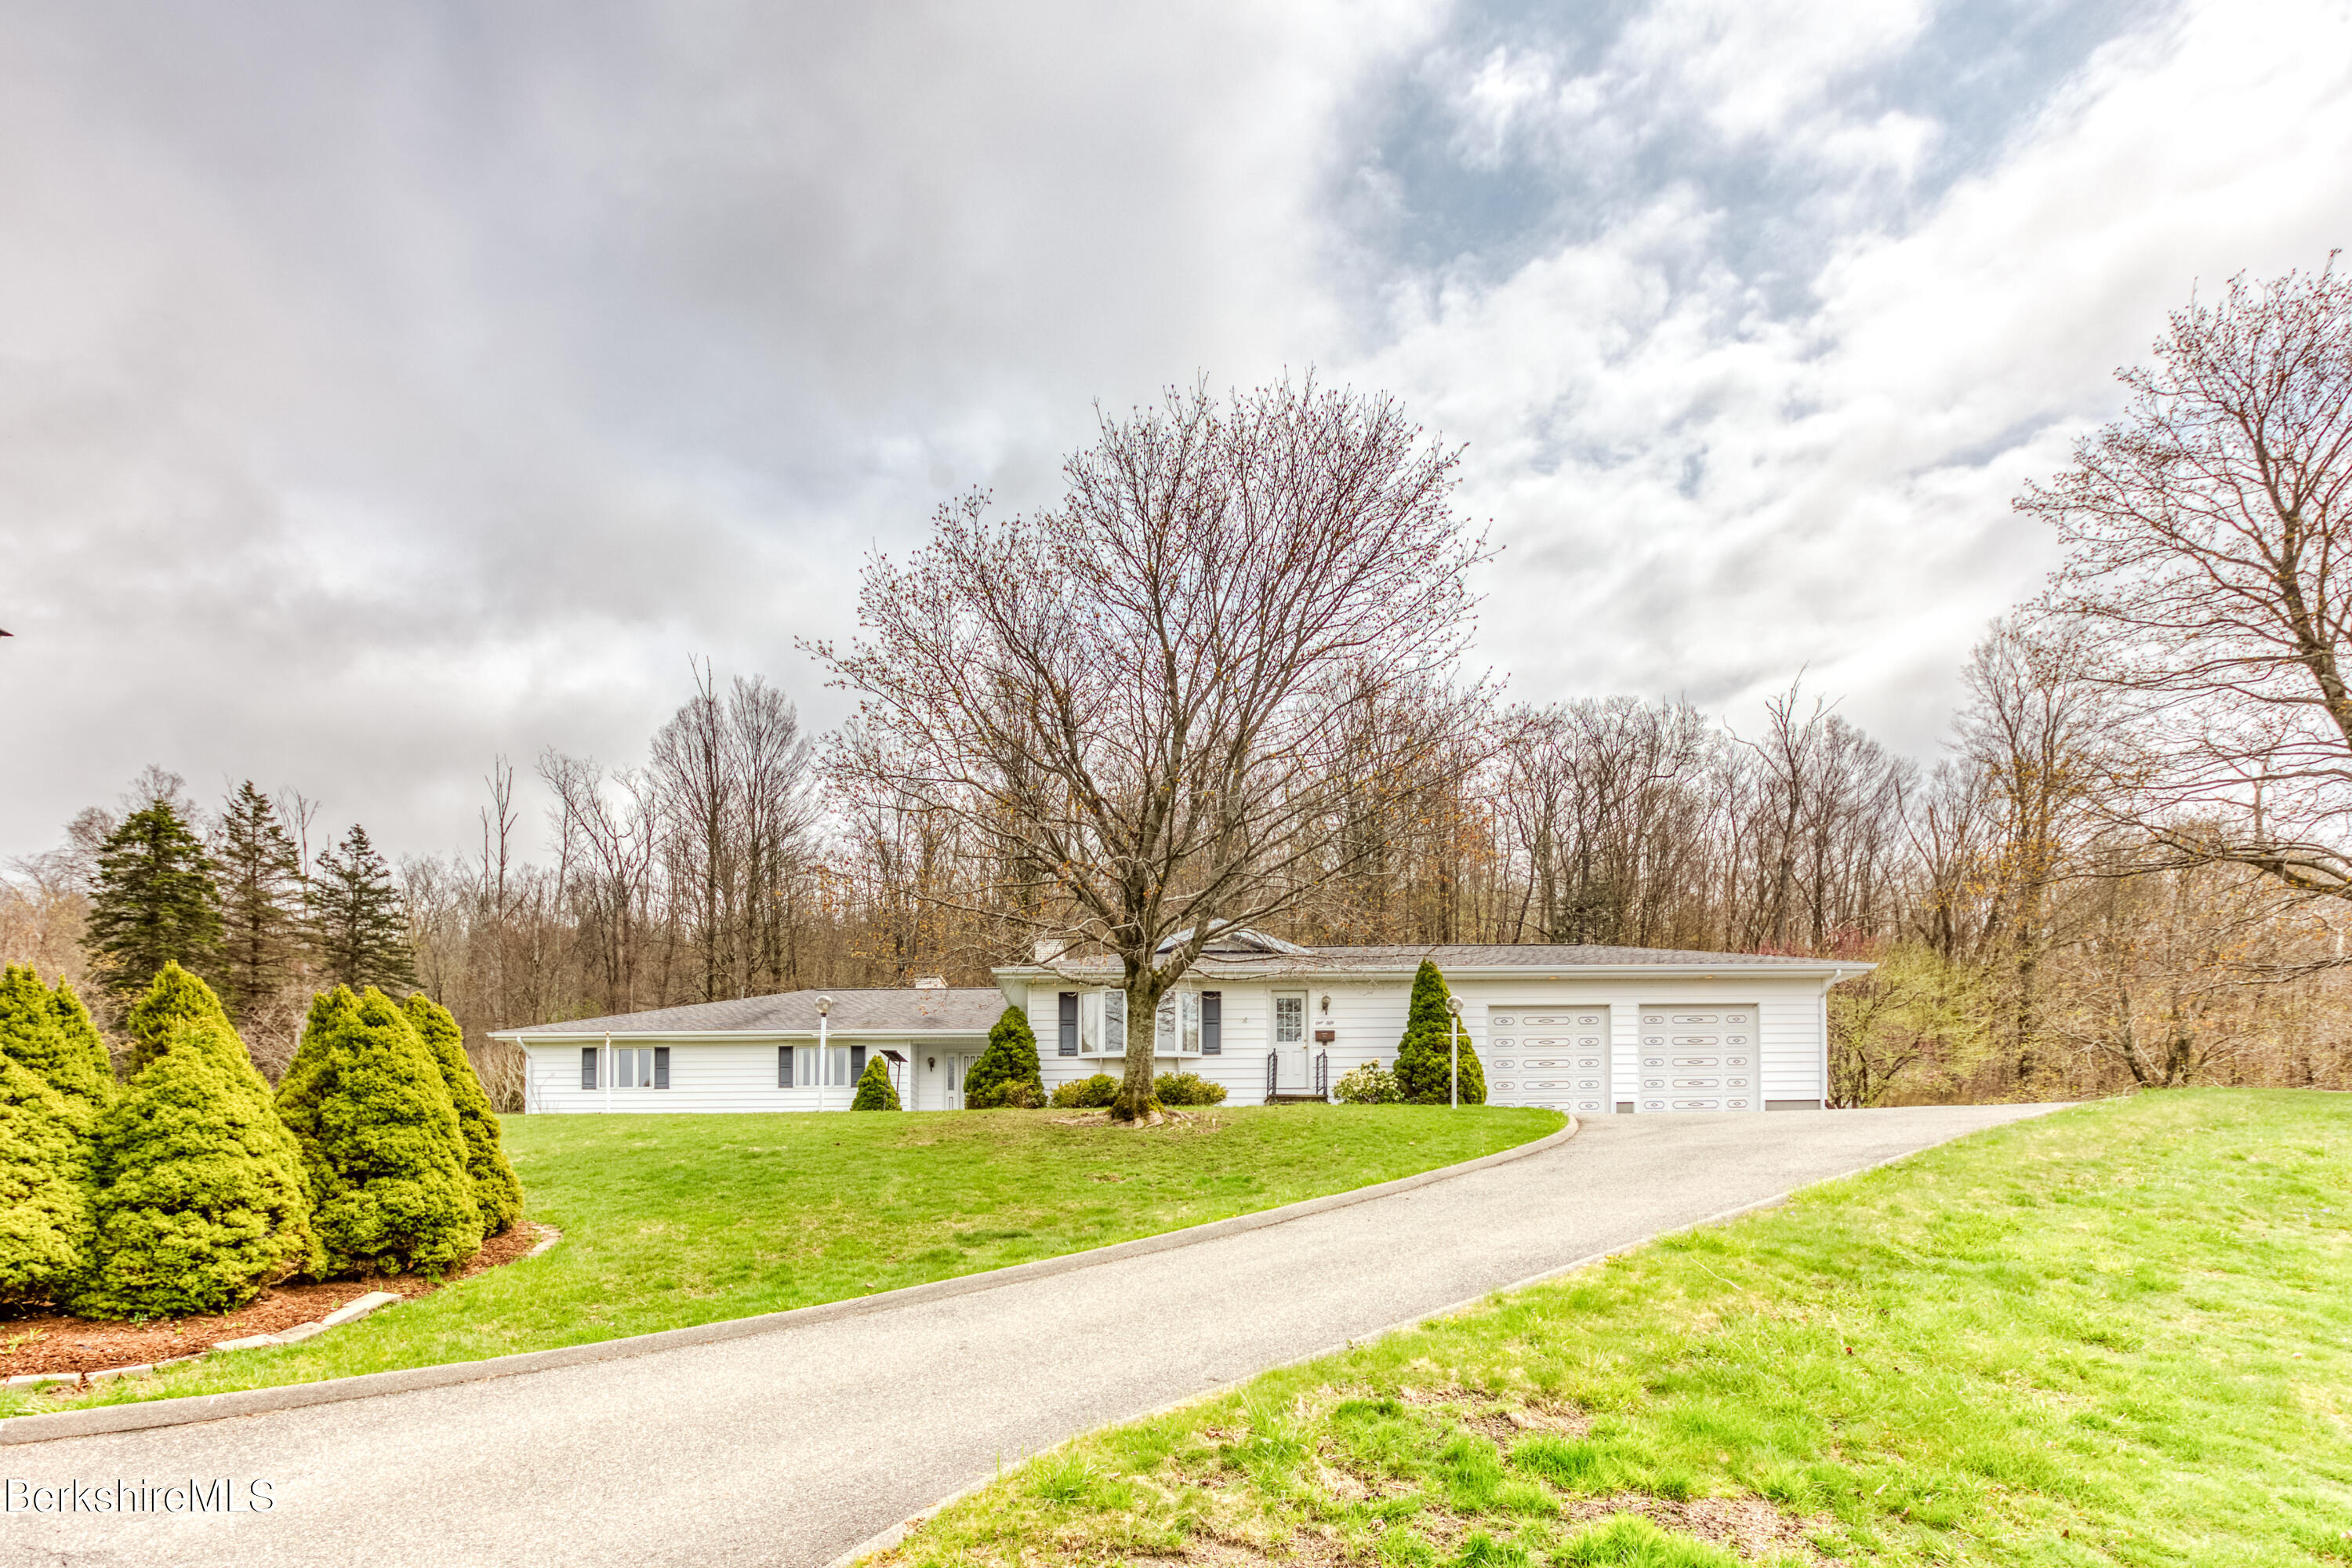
[{"left": 0, "top": 1220, "right": 553, "bottom": 1377}]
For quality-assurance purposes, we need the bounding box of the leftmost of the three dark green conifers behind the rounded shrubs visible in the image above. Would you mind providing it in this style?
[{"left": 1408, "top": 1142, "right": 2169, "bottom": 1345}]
[{"left": 82, "top": 799, "right": 221, "bottom": 996}]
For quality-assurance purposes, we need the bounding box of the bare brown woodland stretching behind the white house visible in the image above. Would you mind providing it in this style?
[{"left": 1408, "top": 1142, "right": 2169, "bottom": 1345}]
[{"left": 0, "top": 626, "right": 2352, "bottom": 1109}]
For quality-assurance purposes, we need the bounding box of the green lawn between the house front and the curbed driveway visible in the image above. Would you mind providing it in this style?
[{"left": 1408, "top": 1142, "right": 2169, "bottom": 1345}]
[{"left": 23, "top": 1105, "right": 1564, "bottom": 1413}]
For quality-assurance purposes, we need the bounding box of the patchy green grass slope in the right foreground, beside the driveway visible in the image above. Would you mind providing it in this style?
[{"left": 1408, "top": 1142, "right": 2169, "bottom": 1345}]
[{"left": 884, "top": 1091, "right": 2352, "bottom": 1568}]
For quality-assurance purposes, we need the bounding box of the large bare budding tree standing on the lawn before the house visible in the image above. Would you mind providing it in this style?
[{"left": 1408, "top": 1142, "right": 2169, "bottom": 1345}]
[{"left": 818, "top": 381, "right": 1479, "bottom": 1119}]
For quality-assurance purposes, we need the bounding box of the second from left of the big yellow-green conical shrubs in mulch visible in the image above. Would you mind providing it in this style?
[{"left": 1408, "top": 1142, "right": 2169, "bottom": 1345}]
[{"left": 66, "top": 1018, "right": 315, "bottom": 1316}]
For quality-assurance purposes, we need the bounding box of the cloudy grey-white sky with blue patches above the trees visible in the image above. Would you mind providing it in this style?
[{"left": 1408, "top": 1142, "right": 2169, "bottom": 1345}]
[{"left": 0, "top": 0, "right": 2352, "bottom": 853}]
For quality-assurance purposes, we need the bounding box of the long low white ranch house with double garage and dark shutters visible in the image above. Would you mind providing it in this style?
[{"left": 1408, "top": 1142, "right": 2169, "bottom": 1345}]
[{"left": 494, "top": 931, "right": 1870, "bottom": 1116}]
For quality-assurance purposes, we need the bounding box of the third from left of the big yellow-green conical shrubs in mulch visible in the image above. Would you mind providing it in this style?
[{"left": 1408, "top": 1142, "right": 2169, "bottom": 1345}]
[{"left": 278, "top": 985, "right": 482, "bottom": 1274}]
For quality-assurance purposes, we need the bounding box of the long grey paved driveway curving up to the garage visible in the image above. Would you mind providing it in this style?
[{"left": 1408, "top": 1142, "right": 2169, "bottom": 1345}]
[{"left": 0, "top": 1105, "right": 2051, "bottom": 1568}]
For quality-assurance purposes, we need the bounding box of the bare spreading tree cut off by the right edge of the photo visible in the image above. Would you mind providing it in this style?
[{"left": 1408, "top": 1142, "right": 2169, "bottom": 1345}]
[{"left": 2018, "top": 261, "right": 2352, "bottom": 898}]
